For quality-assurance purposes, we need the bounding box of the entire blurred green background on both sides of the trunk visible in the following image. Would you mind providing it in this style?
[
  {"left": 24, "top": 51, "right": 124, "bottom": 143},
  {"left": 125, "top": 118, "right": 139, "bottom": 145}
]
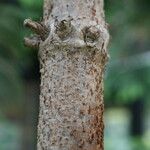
[{"left": 0, "top": 0, "right": 150, "bottom": 150}]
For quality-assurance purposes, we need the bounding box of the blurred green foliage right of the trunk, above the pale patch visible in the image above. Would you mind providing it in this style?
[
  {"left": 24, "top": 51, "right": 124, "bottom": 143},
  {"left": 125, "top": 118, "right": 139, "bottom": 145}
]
[{"left": 105, "top": 0, "right": 150, "bottom": 104}]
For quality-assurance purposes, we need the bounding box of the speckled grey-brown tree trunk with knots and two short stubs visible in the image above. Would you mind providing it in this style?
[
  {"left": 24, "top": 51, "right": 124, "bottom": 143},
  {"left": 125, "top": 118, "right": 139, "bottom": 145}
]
[{"left": 24, "top": 0, "right": 109, "bottom": 150}]
